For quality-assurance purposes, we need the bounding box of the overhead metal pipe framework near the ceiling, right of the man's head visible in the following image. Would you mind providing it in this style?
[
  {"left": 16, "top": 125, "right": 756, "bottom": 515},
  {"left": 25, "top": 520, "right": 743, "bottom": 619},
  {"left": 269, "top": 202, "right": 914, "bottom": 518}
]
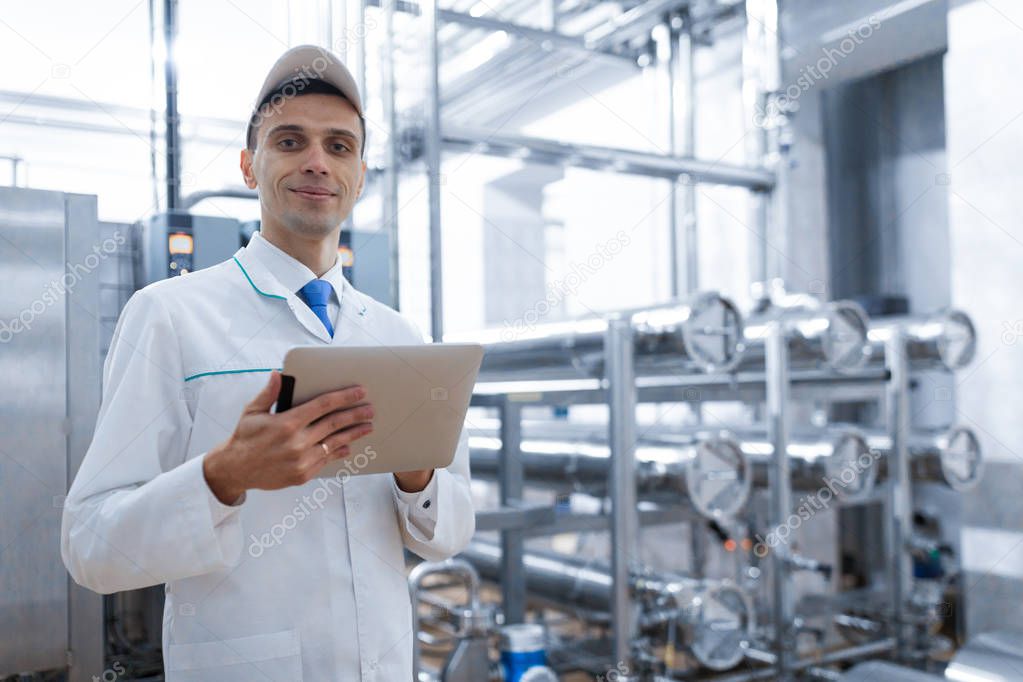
[{"left": 372, "top": 0, "right": 781, "bottom": 339}]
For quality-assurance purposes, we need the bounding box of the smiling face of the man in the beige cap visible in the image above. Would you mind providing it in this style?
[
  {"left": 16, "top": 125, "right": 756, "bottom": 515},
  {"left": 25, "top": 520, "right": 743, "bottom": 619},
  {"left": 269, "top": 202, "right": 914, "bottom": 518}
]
[{"left": 241, "top": 94, "right": 366, "bottom": 236}]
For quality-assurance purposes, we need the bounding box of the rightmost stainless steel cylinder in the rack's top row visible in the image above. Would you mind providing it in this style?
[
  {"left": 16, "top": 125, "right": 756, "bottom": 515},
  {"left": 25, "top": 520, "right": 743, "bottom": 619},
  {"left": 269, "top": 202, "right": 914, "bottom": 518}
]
[{"left": 868, "top": 309, "right": 977, "bottom": 370}]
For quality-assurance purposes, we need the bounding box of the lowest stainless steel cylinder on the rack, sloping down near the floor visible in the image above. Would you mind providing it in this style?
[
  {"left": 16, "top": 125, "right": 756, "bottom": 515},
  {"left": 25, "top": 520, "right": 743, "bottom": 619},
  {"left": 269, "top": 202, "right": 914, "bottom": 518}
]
[{"left": 460, "top": 540, "right": 755, "bottom": 670}]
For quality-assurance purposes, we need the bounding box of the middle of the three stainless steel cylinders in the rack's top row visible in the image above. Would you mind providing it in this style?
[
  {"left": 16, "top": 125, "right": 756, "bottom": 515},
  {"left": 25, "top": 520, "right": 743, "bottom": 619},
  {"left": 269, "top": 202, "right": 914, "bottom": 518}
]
[{"left": 739, "top": 301, "right": 870, "bottom": 371}]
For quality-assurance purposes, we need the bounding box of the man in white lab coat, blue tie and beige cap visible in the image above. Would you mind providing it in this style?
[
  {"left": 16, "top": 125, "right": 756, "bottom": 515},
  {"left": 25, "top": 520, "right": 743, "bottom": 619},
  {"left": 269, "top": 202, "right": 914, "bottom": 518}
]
[{"left": 61, "top": 46, "right": 475, "bottom": 682}]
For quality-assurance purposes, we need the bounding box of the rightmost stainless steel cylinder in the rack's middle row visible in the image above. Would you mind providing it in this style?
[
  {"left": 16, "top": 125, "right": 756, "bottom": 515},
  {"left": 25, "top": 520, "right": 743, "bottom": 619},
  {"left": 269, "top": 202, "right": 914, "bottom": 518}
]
[{"left": 866, "top": 426, "right": 984, "bottom": 492}]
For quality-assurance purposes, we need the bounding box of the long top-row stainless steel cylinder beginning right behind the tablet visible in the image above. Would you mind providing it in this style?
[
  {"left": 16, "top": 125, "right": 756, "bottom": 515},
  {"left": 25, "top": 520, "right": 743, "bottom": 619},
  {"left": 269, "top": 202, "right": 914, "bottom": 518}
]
[{"left": 464, "top": 292, "right": 743, "bottom": 381}]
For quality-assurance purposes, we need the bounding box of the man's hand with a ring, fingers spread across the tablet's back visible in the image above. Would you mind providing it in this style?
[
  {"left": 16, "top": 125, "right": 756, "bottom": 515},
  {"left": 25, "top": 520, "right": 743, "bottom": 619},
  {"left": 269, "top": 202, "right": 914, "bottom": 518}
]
[{"left": 203, "top": 371, "right": 373, "bottom": 504}]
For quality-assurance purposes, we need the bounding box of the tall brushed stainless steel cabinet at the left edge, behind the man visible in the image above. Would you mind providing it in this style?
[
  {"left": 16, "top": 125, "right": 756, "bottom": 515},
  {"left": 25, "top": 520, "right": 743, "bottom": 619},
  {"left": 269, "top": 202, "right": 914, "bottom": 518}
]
[{"left": 0, "top": 187, "right": 102, "bottom": 682}]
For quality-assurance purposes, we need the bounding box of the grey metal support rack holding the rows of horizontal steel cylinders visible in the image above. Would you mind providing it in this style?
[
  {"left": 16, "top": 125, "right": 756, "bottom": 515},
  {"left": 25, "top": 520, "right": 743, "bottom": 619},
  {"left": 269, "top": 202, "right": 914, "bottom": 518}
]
[{"left": 401, "top": 298, "right": 982, "bottom": 682}]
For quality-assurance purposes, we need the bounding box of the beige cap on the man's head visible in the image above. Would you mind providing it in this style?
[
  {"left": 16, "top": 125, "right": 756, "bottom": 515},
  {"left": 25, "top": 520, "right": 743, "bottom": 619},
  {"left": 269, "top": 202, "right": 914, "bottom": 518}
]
[{"left": 246, "top": 45, "right": 362, "bottom": 147}]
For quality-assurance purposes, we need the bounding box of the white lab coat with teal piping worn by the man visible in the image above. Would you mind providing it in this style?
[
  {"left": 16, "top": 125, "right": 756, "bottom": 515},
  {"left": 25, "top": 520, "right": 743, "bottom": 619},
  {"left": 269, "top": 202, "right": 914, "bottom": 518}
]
[{"left": 61, "top": 232, "right": 475, "bottom": 682}]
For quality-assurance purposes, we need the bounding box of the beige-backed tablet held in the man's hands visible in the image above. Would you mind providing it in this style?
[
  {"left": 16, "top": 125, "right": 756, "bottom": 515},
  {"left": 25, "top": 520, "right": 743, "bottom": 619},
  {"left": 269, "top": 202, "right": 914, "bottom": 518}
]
[{"left": 276, "top": 344, "right": 483, "bottom": 478}]
